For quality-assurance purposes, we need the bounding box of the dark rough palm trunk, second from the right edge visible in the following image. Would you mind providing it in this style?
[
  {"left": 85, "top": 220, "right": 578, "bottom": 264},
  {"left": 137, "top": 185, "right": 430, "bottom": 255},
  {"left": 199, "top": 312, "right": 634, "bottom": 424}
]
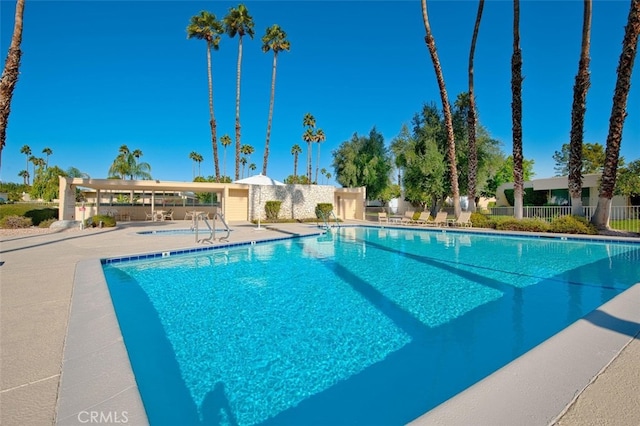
[{"left": 569, "top": 0, "right": 591, "bottom": 216}]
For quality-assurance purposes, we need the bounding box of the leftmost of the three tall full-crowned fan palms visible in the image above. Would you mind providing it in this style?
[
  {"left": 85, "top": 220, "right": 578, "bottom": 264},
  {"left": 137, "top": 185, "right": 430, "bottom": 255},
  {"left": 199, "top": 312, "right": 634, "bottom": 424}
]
[{"left": 187, "top": 10, "right": 224, "bottom": 180}]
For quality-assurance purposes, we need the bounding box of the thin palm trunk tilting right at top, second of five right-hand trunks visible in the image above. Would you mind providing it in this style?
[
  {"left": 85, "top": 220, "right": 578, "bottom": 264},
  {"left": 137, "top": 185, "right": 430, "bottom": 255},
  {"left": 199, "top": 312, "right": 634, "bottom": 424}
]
[{"left": 467, "top": 0, "right": 484, "bottom": 212}]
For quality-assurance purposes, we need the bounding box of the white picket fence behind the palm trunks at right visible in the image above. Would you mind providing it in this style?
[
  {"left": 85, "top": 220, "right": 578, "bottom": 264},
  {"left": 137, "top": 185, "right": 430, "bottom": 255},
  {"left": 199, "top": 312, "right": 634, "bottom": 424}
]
[{"left": 489, "top": 206, "right": 640, "bottom": 232}]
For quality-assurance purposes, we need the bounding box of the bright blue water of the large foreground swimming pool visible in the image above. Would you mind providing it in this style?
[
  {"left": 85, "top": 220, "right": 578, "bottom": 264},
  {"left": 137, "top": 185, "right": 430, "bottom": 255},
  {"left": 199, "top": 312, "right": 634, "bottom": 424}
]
[{"left": 104, "top": 228, "right": 640, "bottom": 425}]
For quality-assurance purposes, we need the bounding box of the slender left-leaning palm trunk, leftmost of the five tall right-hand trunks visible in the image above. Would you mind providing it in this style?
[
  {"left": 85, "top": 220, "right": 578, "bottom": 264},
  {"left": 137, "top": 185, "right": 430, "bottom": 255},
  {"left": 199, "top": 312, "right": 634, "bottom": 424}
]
[{"left": 421, "top": 0, "right": 461, "bottom": 217}]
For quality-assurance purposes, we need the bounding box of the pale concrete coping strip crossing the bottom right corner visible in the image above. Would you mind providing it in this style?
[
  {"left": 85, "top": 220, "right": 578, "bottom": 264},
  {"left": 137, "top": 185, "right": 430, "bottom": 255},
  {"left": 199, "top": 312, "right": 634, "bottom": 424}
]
[{"left": 411, "top": 283, "right": 640, "bottom": 426}]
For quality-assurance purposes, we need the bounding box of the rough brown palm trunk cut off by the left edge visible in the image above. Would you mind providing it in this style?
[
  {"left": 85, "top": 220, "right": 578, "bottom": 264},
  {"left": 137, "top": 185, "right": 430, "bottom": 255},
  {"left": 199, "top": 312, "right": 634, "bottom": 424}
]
[{"left": 0, "top": 0, "right": 28, "bottom": 171}]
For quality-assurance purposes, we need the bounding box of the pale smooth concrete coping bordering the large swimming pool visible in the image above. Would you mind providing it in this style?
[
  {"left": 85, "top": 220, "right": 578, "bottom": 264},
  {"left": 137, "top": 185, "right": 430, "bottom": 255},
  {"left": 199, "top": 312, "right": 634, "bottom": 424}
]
[{"left": 56, "top": 225, "right": 640, "bottom": 425}]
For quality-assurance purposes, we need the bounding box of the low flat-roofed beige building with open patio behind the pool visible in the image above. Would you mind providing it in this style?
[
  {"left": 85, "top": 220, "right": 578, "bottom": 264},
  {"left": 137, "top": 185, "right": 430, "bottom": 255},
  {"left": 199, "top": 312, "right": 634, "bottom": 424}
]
[{"left": 59, "top": 177, "right": 366, "bottom": 221}]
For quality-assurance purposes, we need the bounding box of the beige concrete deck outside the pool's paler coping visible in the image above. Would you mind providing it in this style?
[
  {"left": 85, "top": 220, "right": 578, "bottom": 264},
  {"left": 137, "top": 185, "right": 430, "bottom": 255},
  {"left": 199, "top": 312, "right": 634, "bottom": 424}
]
[{"left": 0, "top": 221, "right": 640, "bottom": 426}]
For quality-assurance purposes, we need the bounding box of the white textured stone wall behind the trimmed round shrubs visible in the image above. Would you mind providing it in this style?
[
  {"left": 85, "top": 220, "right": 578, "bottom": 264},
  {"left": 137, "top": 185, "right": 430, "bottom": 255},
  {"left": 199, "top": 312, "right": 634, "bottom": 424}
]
[{"left": 249, "top": 185, "right": 336, "bottom": 220}]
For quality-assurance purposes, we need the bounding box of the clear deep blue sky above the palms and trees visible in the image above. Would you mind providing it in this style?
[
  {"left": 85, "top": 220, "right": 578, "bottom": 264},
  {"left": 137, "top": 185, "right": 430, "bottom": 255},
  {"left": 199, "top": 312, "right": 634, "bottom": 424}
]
[{"left": 0, "top": 0, "right": 640, "bottom": 186}]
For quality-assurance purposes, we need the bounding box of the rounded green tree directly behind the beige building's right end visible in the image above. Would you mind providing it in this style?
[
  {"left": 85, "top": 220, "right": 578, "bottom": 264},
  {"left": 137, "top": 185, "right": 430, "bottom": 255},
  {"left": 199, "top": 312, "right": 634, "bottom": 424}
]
[{"left": 333, "top": 127, "right": 391, "bottom": 200}]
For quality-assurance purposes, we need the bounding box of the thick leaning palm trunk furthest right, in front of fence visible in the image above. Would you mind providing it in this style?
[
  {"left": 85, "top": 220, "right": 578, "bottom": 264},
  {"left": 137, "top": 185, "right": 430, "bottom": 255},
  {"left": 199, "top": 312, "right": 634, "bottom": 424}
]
[{"left": 591, "top": 0, "right": 640, "bottom": 229}]
